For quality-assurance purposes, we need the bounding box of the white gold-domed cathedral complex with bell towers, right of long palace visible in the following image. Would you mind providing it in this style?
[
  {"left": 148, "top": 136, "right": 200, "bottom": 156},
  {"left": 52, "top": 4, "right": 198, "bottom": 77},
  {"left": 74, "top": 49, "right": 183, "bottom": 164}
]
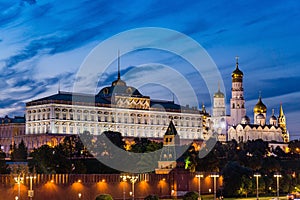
[{"left": 210, "top": 58, "right": 289, "bottom": 143}]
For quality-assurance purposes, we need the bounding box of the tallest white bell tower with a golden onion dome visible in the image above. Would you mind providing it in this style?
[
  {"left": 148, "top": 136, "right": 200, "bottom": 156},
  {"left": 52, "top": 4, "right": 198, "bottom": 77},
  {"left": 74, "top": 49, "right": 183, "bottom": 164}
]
[{"left": 230, "top": 56, "right": 246, "bottom": 125}]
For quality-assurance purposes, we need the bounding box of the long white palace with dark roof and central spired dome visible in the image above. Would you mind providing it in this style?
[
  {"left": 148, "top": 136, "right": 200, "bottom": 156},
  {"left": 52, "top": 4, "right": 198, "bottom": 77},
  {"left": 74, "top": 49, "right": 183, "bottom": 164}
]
[{"left": 26, "top": 64, "right": 209, "bottom": 140}]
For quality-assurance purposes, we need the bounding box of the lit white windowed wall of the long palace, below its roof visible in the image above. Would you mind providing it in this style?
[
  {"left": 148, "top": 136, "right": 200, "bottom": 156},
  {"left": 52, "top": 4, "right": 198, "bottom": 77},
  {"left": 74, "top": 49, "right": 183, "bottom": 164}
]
[{"left": 26, "top": 104, "right": 203, "bottom": 139}]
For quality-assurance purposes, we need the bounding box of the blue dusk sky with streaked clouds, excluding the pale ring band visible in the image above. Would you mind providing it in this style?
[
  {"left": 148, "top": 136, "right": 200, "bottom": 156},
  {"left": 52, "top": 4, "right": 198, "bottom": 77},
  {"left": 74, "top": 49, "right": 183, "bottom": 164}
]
[{"left": 0, "top": 0, "right": 300, "bottom": 139}]
